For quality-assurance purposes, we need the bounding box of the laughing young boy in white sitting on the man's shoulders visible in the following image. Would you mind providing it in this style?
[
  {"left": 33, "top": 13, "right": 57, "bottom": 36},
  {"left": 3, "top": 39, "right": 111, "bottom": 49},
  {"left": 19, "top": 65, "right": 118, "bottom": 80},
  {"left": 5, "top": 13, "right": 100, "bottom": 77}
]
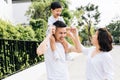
[{"left": 46, "top": 2, "right": 72, "bottom": 60}]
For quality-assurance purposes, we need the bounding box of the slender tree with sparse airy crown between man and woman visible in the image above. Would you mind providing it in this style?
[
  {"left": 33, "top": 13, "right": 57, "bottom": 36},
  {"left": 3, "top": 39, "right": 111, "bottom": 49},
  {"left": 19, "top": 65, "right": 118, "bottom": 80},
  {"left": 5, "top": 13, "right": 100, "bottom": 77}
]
[{"left": 75, "top": 4, "right": 100, "bottom": 42}]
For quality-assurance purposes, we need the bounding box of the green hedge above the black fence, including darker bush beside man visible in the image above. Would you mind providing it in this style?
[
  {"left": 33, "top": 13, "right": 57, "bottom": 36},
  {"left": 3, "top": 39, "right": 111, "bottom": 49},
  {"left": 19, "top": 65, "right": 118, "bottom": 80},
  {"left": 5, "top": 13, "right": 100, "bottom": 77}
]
[{"left": 0, "top": 19, "right": 47, "bottom": 41}]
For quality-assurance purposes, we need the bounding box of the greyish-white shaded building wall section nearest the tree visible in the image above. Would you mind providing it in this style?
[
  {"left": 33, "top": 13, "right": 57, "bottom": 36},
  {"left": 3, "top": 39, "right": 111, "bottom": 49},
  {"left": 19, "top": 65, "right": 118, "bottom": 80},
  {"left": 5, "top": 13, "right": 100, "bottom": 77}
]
[{"left": 12, "top": 1, "right": 31, "bottom": 24}]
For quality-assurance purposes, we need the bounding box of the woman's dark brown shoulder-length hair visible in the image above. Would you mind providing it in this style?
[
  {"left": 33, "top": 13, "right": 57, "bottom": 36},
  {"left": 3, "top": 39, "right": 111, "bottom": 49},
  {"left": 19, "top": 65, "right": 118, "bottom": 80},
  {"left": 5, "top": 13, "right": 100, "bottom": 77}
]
[{"left": 97, "top": 28, "right": 112, "bottom": 52}]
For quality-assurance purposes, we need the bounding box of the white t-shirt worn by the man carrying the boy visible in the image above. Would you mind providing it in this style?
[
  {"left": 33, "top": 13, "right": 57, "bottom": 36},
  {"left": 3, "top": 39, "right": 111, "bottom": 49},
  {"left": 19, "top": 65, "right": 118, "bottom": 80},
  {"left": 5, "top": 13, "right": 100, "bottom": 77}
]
[{"left": 44, "top": 43, "right": 69, "bottom": 80}]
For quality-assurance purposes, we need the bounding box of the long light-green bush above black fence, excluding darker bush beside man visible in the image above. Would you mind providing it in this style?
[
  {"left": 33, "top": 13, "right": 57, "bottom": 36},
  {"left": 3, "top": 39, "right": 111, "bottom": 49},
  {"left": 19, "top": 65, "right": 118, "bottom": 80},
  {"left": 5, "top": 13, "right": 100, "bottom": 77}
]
[{"left": 0, "top": 20, "right": 36, "bottom": 40}]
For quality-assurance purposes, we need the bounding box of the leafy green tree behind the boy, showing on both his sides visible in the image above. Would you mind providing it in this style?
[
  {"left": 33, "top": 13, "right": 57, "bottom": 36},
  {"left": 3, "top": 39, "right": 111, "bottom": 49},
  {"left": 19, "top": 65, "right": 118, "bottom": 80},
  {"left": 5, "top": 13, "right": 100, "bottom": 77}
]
[{"left": 26, "top": 0, "right": 71, "bottom": 22}]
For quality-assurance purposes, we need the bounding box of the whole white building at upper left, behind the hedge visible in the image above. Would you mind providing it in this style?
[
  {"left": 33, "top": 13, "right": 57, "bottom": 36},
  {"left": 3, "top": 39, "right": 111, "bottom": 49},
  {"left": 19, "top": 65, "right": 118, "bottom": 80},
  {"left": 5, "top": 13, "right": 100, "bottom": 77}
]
[{"left": 0, "top": 0, "right": 31, "bottom": 24}]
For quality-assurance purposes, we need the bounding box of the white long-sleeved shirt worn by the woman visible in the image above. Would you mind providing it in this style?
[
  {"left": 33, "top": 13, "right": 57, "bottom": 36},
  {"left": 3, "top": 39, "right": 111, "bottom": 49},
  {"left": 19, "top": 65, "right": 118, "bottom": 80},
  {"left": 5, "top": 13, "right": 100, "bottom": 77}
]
[{"left": 82, "top": 47, "right": 113, "bottom": 80}]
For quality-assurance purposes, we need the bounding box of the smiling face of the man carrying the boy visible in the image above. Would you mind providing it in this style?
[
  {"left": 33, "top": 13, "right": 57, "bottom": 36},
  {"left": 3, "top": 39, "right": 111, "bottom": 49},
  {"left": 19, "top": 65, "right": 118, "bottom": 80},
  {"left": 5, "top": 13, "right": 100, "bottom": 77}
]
[{"left": 55, "top": 27, "right": 66, "bottom": 42}]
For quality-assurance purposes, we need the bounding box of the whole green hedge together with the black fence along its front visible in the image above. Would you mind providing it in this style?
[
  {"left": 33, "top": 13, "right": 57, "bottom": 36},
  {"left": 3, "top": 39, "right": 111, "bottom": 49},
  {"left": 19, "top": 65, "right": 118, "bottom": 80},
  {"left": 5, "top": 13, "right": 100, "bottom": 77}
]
[{"left": 0, "top": 19, "right": 47, "bottom": 79}]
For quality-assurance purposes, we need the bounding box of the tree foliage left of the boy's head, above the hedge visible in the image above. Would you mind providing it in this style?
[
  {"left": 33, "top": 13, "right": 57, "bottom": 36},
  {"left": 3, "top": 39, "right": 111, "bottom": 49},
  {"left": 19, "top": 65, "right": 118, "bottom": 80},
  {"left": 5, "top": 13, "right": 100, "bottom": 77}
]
[{"left": 26, "top": 0, "right": 52, "bottom": 21}]
